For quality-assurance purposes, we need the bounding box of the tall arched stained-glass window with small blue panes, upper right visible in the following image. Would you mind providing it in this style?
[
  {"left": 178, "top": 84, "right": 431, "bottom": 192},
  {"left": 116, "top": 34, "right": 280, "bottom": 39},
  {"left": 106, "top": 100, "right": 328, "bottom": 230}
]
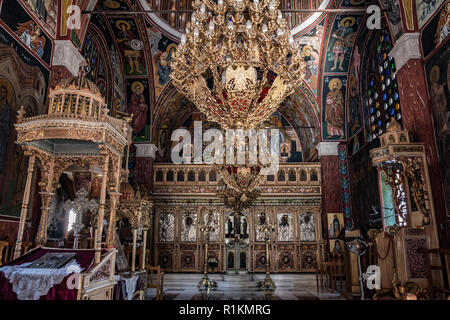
[{"left": 367, "top": 29, "right": 402, "bottom": 139}]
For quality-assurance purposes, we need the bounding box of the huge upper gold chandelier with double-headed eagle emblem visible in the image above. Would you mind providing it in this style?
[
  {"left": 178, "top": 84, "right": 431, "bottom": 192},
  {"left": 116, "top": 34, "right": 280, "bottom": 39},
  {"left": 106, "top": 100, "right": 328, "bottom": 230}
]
[{"left": 170, "top": 0, "right": 306, "bottom": 129}]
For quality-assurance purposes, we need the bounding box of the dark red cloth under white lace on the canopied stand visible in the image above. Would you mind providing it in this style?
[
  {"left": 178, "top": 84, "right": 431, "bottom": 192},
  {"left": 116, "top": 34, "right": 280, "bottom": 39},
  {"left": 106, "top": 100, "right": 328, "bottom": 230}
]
[{"left": 0, "top": 248, "right": 97, "bottom": 300}]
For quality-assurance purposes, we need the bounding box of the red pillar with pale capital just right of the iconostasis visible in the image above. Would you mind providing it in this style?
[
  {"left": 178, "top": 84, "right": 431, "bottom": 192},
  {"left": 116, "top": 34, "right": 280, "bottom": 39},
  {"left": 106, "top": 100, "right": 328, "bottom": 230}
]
[{"left": 316, "top": 142, "right": 343, "bottom": 235}]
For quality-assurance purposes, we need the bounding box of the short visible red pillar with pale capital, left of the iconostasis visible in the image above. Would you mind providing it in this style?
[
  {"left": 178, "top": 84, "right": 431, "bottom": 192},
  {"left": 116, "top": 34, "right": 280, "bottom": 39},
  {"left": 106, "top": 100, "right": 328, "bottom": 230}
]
[{"left": 135, "top": 143, "right": 158, "bottom": 190}]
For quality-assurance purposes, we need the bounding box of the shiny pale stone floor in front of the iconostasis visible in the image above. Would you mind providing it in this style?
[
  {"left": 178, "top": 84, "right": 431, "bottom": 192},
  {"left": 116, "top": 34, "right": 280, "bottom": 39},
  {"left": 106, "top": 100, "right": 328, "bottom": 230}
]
[{"left": 146, "top": 273, "right": 346, "bottom": 300}]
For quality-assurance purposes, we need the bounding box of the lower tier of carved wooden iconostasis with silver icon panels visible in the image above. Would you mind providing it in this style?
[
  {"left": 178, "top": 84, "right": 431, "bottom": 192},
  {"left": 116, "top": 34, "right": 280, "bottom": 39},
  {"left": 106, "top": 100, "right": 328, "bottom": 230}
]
[{"left": 153, "top": 198, "right": 323, "bottom": 272}]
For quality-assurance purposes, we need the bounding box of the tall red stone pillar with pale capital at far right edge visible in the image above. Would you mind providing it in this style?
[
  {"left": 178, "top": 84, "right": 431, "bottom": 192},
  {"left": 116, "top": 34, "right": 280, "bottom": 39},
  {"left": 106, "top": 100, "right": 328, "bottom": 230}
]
[{"left": 389, "top": 33, "right": 450, "bottom": 246}]
